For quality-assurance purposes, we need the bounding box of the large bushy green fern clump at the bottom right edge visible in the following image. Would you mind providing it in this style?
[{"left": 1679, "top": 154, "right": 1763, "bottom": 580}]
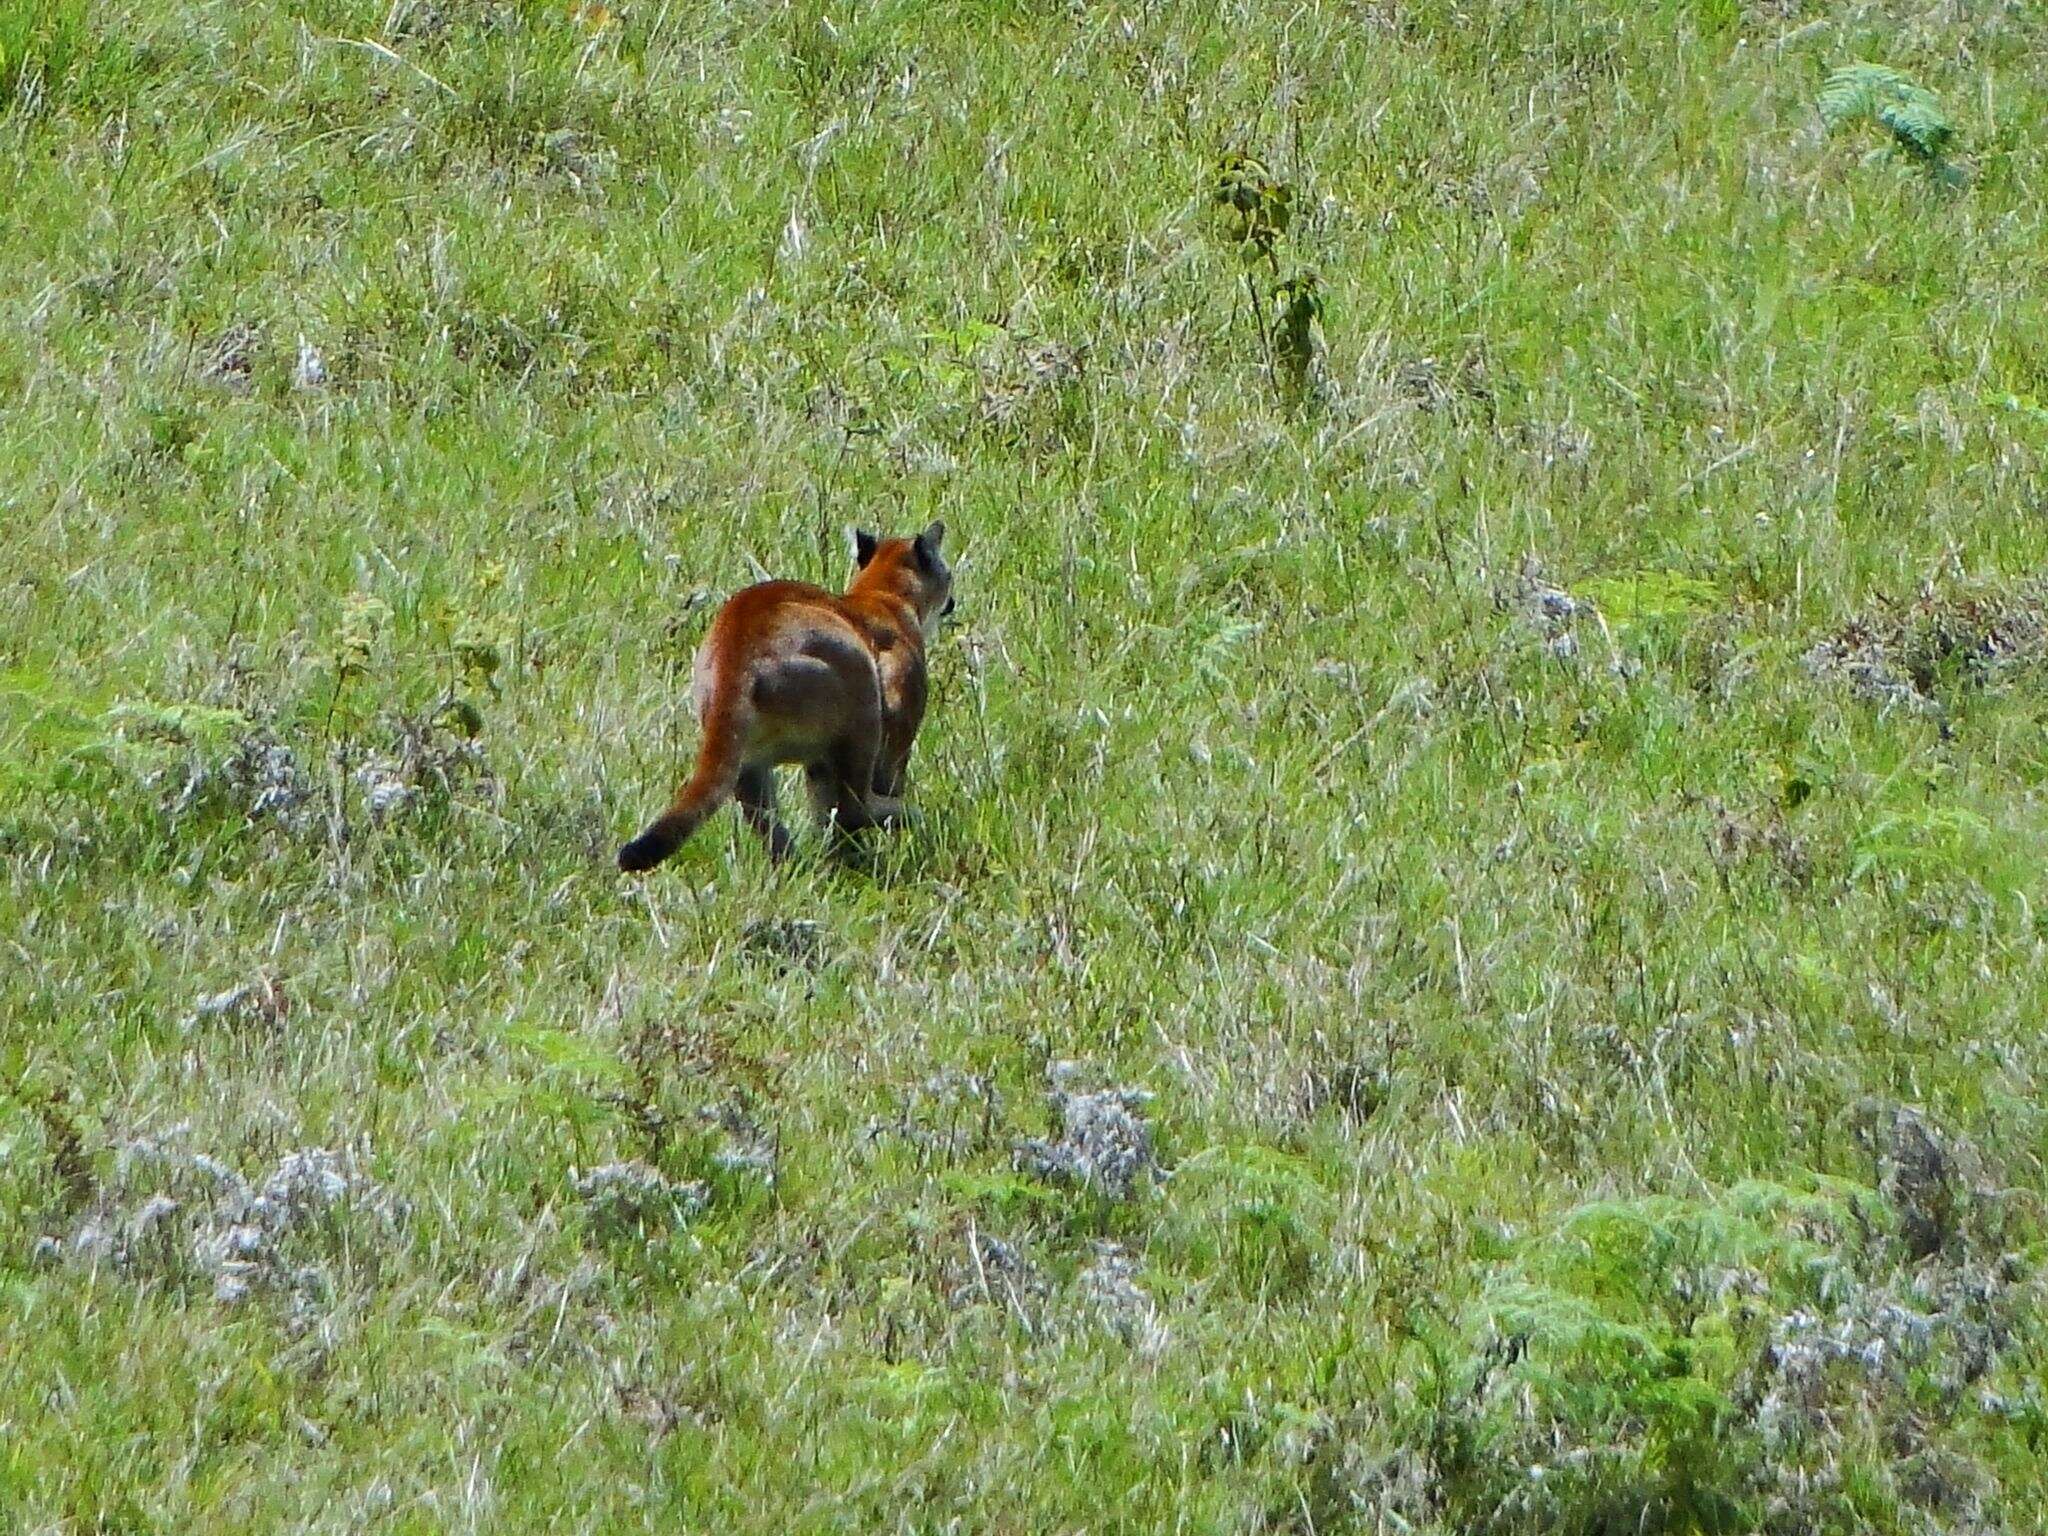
[{"left": 1417, "top": 1176, "right": 1892, "bottom": 1532}]
